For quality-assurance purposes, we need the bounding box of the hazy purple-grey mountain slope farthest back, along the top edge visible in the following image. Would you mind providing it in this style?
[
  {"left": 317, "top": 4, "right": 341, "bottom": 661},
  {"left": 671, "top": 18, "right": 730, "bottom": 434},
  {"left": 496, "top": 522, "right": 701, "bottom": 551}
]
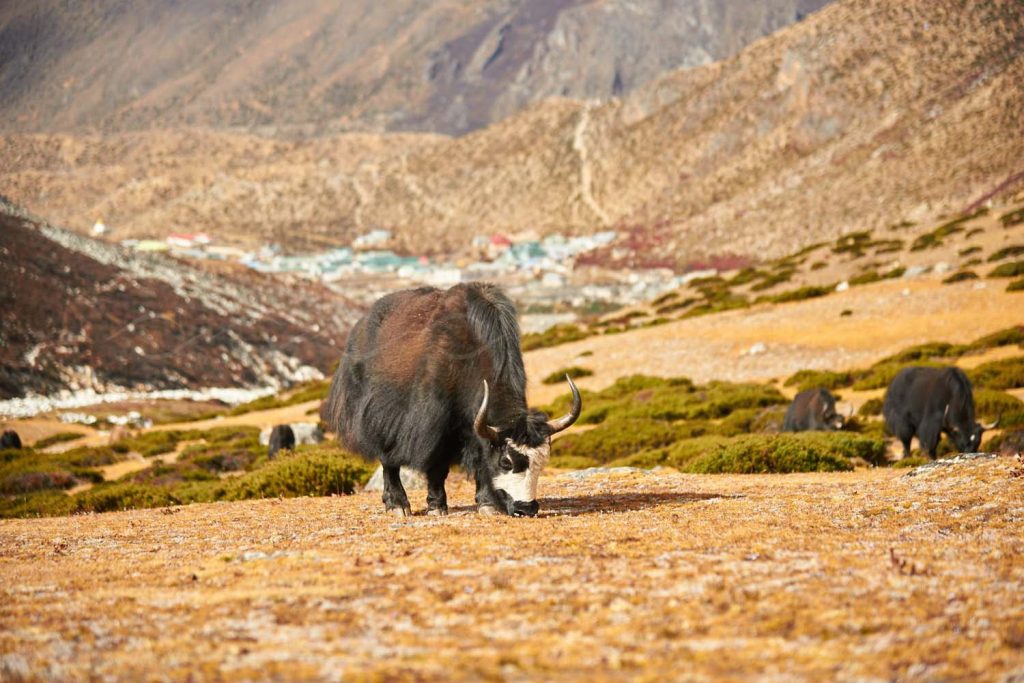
[{"left": 0, "top": 0, "right": 827, "bottom": 133}]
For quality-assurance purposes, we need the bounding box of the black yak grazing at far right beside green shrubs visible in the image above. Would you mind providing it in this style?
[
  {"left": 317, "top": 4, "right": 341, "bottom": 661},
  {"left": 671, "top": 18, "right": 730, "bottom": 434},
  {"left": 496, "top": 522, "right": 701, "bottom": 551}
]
[{"left": 882, "top": 368, "right": 999, "bottom": 460}]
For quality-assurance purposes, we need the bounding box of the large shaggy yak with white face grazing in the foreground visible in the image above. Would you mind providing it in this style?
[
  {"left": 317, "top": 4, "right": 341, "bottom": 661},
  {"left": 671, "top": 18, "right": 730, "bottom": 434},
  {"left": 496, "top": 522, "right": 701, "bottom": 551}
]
[{"left": 324, "top": 283, "right": 582, "bottom": 517}]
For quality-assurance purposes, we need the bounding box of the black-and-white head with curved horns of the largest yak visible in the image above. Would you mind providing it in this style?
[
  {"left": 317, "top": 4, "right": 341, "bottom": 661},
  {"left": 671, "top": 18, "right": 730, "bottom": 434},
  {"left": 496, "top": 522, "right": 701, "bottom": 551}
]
[{"left": 473, "top": 375, "right": 583, "bottom": 517}]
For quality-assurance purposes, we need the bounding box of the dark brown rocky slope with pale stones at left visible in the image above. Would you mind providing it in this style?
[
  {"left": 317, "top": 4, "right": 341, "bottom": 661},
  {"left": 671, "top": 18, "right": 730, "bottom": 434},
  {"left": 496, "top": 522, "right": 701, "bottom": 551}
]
[{"left": 0, "top": 202, "right": 356, "bottom": 398}]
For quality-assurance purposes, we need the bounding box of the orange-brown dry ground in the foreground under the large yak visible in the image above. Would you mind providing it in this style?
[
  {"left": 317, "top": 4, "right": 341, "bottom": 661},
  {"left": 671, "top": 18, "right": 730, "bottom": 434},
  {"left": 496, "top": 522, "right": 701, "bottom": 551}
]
[{"left": 0, "top": 458, "right": 1024, "bottom": 681}]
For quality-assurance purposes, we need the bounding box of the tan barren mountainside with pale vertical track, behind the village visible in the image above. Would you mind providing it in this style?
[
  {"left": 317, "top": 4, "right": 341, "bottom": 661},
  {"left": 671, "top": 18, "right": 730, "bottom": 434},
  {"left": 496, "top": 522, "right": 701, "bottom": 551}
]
[{"left": 0, "top": 0, "right": 1024, "bottom": 264}]
